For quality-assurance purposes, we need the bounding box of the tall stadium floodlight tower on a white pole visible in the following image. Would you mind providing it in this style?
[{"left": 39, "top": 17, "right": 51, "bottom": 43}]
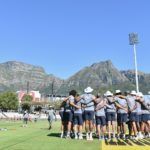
[{"left": 129, "top": 33, "right": 139, "bottom": 92}]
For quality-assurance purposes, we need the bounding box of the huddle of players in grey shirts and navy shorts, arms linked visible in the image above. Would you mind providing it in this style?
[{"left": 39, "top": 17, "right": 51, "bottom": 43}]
[{"left": 60, "top": 87, "right": 150, "bottom": 140}]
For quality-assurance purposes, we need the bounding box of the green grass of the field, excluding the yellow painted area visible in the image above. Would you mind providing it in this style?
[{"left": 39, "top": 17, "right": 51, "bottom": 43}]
[{"left": 0, "top": 121, "right": 101, "bottom": 150}]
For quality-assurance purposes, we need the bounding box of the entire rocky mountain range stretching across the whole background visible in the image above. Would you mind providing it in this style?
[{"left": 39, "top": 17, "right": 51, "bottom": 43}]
[{"left": 0, "top": 60, "right": 150, "bottom": 94}]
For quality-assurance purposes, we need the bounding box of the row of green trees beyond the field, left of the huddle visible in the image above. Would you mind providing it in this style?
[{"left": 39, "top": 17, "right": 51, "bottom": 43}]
[{"left": 0, "top": 92, "right": 62, "bottom": 111}]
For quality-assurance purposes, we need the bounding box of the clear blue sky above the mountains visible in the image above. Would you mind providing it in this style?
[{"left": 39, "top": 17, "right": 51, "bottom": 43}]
[{"left": 0, "top": 0, "right": 150, "bottom": 79}]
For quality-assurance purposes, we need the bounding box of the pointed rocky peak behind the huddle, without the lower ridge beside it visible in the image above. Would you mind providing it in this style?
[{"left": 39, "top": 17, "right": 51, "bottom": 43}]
[{"left": 59, "top": 60, "right": 132, "bottom": 92}]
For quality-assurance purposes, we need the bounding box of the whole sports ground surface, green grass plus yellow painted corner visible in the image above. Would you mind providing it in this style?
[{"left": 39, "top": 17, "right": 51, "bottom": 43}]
[{"left": 0, "top": 121, "right": 150, "bottom": 150}]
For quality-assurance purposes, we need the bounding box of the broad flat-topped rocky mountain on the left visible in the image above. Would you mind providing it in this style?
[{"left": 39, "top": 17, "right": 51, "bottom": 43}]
[{"left": 0, "top": 61, "right": 63, "bottom": 94}]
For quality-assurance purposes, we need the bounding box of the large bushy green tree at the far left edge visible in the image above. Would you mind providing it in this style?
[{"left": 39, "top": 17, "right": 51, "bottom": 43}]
[{"left": 0, "top": 92, "right": 19, "bottom": 110}]
